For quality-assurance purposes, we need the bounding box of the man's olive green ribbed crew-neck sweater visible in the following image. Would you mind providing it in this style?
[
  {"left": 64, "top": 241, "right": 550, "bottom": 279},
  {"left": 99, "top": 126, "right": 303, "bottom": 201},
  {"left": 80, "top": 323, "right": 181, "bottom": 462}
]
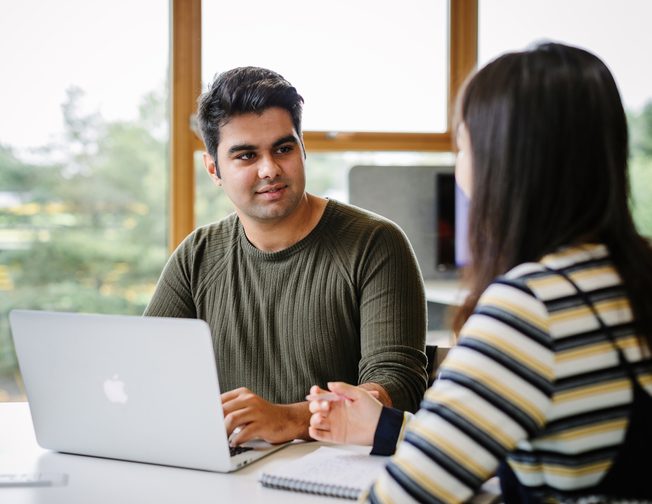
[{"left": 145, "top": 200, "right": 426, "bottom": 411}]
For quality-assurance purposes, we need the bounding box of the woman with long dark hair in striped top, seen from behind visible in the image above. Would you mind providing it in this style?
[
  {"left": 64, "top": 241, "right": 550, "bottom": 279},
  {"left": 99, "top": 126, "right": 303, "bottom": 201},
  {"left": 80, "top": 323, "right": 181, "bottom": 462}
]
[{"left": 310, "top": 43, "right": 652, "bottom": 502}]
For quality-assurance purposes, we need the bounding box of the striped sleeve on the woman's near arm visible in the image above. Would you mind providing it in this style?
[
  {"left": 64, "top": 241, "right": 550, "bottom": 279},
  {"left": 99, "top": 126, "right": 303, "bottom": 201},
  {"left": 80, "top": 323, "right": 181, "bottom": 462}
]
[{"left": 363, "top": 281, "right": 554, "bottom": 502}]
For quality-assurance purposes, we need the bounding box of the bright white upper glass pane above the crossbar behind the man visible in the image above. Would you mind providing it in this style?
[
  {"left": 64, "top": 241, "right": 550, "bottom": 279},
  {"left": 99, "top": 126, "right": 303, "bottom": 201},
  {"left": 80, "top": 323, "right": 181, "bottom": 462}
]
[{"left": 202, "top": 0, "right": 448, "bottom": 132}]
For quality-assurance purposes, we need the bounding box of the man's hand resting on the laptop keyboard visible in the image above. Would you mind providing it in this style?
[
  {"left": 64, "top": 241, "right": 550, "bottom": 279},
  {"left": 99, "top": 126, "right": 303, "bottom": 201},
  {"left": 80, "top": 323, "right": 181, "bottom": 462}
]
[{"left": 222, "top": 387, "right": 310, "bottom": 446}]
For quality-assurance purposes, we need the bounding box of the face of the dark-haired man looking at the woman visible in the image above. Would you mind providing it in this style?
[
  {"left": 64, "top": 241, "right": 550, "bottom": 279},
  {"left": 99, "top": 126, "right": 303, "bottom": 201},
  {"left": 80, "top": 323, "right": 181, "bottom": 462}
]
[{"left": 204, "top": 107, "right": 306, "bottom": 222}]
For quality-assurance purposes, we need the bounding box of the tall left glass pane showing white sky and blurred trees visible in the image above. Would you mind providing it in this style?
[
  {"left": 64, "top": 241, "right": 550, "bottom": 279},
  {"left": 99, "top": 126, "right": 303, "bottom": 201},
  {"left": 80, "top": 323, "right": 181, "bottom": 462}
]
[{"left": 0, "top": 0, "right": 169, "bottom": 400}]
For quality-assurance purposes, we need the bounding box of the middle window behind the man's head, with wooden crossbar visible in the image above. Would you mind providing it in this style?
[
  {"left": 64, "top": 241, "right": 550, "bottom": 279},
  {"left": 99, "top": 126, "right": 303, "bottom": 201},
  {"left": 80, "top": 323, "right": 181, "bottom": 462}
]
[{"left": 194, "top": 0, "right": 475, "bottom": 225}]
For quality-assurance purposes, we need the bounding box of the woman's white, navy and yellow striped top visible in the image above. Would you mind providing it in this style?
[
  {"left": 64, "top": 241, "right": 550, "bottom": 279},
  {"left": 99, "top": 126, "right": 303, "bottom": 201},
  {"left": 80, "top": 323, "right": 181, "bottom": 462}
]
[{"left": 364, "top": 244, "right": 652, "bottom": 502}]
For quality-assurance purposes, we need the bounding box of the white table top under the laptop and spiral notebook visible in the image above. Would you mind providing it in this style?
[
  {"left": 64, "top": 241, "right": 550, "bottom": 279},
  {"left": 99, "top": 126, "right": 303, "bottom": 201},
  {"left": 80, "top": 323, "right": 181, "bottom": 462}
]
[{"left": 0, "top": 403, "right": 356, "bottom": 504}]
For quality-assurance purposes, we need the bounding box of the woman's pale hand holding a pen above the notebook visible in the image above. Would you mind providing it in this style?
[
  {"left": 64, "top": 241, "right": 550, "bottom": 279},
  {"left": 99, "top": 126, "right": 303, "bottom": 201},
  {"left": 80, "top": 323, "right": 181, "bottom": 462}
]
[{"left": 308, "top": 382, "right": 383, "bottom": 445}]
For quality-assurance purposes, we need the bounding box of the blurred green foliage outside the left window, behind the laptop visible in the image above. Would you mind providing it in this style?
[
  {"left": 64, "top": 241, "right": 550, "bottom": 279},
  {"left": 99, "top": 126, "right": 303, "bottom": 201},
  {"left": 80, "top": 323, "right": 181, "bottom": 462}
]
[{"left": 0, "top": 88, "right": 168, "bottom": 398}]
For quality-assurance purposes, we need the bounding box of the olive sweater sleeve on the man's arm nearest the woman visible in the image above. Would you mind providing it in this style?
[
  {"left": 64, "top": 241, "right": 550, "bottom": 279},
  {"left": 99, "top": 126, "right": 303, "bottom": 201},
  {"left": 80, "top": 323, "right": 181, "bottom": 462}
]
[{"left": 358, "top": 222, "right": 427, "bottom": 411}]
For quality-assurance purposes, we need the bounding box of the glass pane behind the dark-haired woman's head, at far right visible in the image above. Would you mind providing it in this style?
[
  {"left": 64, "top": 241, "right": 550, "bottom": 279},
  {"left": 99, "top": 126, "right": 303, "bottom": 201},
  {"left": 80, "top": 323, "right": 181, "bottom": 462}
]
[{"left": 478, "top": 0, "right": 652, "bottom": 237}]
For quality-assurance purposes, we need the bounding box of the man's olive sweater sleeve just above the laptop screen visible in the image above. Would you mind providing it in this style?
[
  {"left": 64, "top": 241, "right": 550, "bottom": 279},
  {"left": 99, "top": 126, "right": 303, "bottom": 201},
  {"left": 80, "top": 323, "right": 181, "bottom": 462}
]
[{"left": 144, "top": 238, "right": 197, "bottom": 318}]
